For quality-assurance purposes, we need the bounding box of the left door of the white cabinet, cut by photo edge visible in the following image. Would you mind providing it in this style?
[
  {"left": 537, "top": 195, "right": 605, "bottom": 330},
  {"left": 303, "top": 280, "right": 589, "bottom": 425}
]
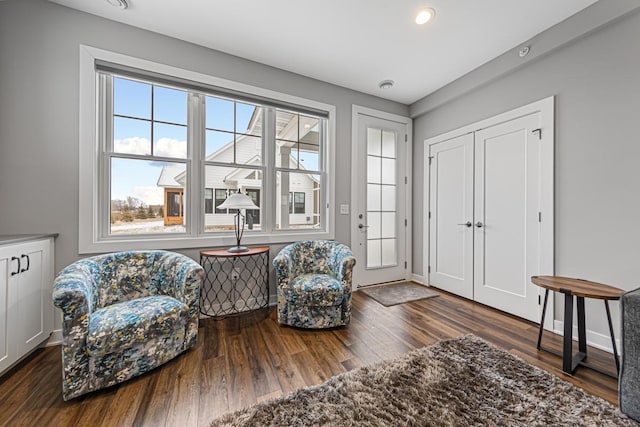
[{"left": 0, "top": 246, "right": 18, "bottom": 372}]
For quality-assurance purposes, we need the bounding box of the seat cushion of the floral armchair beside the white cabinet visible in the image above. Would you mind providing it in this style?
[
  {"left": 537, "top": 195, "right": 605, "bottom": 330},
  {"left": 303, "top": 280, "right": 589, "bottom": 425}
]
[{"left": 87, "top": 295, "right": 188, "bottom": 356}]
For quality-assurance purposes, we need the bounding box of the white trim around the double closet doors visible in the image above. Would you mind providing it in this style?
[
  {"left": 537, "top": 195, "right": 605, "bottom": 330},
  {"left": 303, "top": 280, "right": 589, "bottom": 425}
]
[{"left": 422, "top": 96, "right": 555, "bottom": 330}]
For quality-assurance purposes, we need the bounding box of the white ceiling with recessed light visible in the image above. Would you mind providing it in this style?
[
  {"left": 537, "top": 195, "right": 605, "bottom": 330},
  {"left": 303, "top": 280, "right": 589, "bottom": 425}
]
[{"left": 50, "top": 0, "right": 596, "bottom": 104}]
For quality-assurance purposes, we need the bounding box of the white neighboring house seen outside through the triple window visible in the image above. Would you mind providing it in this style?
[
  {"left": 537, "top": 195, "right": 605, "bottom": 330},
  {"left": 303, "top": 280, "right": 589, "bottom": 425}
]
[{"left": 158, "top": 107, "right": 320, "bottom": 231}]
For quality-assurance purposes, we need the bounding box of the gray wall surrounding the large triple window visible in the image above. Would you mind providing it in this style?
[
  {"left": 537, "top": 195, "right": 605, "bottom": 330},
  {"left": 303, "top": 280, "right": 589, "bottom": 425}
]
[{"left": 0, "top": 0, "right": 408, "bottom": 271}]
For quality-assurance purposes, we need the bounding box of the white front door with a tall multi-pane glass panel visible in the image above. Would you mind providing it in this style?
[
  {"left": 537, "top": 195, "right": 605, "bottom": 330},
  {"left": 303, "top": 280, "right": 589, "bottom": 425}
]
[{"left": 351, "top": 110, "right": 409, "bottom": 287}]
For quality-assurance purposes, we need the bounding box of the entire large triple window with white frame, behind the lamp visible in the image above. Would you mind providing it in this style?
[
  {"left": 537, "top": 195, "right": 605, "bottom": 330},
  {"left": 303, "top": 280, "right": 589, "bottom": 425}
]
[{"left": 80, "top": 46, "right": 335, "bottom": 253}]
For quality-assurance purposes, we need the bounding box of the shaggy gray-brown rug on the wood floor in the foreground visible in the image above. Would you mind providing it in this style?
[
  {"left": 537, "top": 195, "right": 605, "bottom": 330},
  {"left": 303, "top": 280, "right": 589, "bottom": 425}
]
[{"left": 211, "top": 335, "right": 637, "bottom": 427}]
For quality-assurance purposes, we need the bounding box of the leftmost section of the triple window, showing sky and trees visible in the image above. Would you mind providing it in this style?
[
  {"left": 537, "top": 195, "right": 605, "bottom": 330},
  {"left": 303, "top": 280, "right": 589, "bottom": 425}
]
[{"left": 104, "top": 77, "right": 187, "bottom": 235}]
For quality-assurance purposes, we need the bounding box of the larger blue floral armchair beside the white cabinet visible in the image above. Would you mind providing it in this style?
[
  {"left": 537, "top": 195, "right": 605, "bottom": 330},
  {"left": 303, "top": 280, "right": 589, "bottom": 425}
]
[{"left": 53, "top": 251, "right": 203, "bottom": 400}]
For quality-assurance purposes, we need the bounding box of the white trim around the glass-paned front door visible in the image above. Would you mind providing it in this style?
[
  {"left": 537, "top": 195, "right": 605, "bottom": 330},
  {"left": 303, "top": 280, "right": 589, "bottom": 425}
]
[{"left": 350, "top": 104, "right": 413, "bottom": 290}]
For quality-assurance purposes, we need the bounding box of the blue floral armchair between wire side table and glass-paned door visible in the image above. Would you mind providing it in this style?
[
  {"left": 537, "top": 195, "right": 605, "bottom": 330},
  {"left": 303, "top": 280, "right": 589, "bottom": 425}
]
[{"left": 273, "top": 240, "right": 356, "bottom": 328}]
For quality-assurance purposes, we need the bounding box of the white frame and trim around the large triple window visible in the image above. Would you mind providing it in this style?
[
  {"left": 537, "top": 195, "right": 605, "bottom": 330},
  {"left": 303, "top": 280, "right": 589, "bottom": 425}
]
[{"left": 78, "top": 45, "right": 336, "bottom": 254}]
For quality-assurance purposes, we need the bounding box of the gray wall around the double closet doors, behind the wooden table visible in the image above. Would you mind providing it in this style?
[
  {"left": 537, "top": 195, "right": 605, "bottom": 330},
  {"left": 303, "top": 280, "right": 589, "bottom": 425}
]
[{"left": 413, "top": 9, "right": 640, "bottom": 336}]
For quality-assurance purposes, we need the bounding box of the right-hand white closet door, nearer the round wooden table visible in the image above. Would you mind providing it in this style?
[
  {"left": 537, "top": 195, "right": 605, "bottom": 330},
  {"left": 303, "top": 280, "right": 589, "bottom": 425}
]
[{"left": 474, "top": 114, "right": 540, "bottom": 321}]
